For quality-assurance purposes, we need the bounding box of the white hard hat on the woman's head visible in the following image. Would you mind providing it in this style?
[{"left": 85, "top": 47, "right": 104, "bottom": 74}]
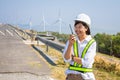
[{"left": 75, "top": 13, "right": 91, "bottom": 26}]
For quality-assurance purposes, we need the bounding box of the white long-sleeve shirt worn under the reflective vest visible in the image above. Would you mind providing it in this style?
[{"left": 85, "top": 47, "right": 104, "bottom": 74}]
[{"left": 63, "top": 35, "right": 96, "bottom": 80}]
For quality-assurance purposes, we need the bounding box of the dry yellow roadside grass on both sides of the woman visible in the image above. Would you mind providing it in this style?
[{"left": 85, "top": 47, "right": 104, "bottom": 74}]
[{"left": 37, "top": 45, "right": 120, "bottom": 80}]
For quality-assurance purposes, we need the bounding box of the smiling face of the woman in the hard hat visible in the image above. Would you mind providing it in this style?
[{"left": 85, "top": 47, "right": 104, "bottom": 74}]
[{"left": 74, "top": 23, "right": 87, "bottom": 37}]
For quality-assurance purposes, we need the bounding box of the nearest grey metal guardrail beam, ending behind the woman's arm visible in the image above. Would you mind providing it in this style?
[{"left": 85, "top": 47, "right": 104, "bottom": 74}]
[{"left": 36, "top": 36, "right": 65, "bottom": 52}]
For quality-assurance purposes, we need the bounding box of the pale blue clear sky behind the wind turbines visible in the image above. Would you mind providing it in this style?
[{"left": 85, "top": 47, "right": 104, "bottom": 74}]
[{"left": 0, "top": 0, "right": 120, "bottom": 34}]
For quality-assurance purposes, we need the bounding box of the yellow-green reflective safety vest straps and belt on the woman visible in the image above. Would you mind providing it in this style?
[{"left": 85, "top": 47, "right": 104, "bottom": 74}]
[{"left": 69, "top": 39, "right": 95, "bottom": 73}]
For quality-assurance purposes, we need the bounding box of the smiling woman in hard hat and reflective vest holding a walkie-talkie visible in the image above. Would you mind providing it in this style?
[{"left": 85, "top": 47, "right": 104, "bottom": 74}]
[{"left": 63, "top": 14, "right": 96, "bottom": 80}]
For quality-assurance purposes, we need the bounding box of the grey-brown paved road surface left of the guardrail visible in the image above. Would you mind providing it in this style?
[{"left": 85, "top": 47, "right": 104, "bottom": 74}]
[{"left": 0, "top": 24, "right": 53, "bottom": 80}]
